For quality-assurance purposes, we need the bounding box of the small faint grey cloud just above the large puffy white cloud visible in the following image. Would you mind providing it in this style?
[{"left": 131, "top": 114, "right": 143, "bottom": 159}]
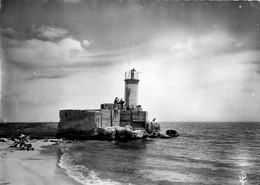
[{"left": 35, "top": 25, "right": 68, "bottom": 40}]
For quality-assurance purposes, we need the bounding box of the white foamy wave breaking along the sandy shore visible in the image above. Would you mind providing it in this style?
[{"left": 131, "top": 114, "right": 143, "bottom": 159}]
[{"left": 58, "top": 149, "right": 125, "bottom": 185}]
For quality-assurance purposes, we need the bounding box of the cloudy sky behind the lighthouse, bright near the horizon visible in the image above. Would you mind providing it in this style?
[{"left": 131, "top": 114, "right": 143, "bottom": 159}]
[{"left": 0, "top": 0, "right": 260, "bottom": 122}]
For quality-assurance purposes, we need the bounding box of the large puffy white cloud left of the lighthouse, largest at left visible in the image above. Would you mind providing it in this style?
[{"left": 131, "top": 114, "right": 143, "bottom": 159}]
[{"left": 6, "top": 38, "right": 85, "bottom": 67}]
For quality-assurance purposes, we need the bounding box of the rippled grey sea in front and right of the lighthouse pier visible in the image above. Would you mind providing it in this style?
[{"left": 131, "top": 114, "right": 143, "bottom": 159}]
[{"left": 59, "top": 122, "right": 260, "bottom": 185}]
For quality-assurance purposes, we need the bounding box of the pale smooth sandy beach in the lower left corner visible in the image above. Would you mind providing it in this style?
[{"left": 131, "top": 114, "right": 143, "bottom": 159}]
[{"left": 0, "top": 140, "right": 79, "bottom": 185}]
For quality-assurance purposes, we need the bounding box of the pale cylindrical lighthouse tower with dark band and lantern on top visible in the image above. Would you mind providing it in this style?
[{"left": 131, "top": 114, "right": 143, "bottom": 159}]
[{"left": 125, "top": 68, "right": 139, "bottom": 109}]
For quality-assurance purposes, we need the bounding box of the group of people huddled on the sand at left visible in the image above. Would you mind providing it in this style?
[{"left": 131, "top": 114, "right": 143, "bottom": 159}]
[{"left": 10, "top": 134, "right": 34, "bottom": 151}]
